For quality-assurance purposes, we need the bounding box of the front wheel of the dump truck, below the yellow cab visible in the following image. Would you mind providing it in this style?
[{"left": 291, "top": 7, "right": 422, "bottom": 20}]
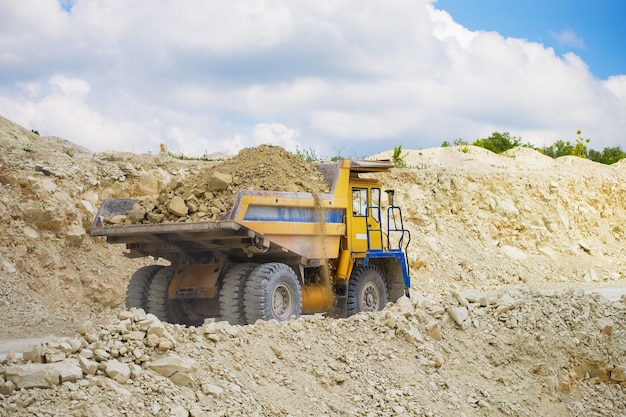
[{"left": 347, "top": 265, "right": 389, "bottom": 316}]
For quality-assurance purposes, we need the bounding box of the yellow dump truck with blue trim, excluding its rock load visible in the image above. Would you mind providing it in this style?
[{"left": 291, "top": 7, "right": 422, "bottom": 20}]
[{"left": 90, "top": 159, "right": 411, "bottom": 325}]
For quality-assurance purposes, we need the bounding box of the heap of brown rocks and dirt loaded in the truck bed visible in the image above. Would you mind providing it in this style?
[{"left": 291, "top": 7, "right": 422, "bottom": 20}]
[{"left": 104, "top": 145, "right": 330, "bottom": 225}]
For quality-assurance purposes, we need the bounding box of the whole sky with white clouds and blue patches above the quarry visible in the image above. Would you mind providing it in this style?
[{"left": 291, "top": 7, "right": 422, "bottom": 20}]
[{"left": 0, "top": 0, "right": 626, "bottom": 158}]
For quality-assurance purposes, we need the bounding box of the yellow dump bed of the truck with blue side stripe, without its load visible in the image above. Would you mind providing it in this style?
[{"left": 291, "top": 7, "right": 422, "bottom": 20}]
[{"left": 91, "top": 190, "right": 345, "bottom": 265}]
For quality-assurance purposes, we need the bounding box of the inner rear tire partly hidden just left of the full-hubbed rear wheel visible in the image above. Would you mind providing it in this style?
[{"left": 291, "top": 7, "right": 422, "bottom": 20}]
[{"left": 219, "top": 263, "right": 258, "bottom": 324}]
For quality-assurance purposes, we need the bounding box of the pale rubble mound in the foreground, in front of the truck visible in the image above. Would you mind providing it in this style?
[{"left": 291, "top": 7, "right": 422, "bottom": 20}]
[{"left": 0, "top": 287, "right": 626, "bottom": 417}]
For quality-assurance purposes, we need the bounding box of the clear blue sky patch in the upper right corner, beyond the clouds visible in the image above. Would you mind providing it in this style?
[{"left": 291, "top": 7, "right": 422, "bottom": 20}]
[{"left": 436, "top": 0, "right": 626, "bottom": 79}]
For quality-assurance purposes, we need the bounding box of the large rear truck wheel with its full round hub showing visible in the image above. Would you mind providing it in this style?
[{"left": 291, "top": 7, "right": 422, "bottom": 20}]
[{"left": 244, "top": 262, "right": 302, "bottom": 324}]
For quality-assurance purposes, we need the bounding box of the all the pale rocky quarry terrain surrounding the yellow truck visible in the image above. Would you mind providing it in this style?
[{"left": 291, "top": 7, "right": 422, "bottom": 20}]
[{"left": 0, "top": 114, "right": 626, "bottom": 416}]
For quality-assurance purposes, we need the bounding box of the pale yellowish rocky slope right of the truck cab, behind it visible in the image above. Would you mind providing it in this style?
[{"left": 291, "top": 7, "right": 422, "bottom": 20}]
[{"left": 378, "top": 146, "right": 626, "bottom": 292}]
